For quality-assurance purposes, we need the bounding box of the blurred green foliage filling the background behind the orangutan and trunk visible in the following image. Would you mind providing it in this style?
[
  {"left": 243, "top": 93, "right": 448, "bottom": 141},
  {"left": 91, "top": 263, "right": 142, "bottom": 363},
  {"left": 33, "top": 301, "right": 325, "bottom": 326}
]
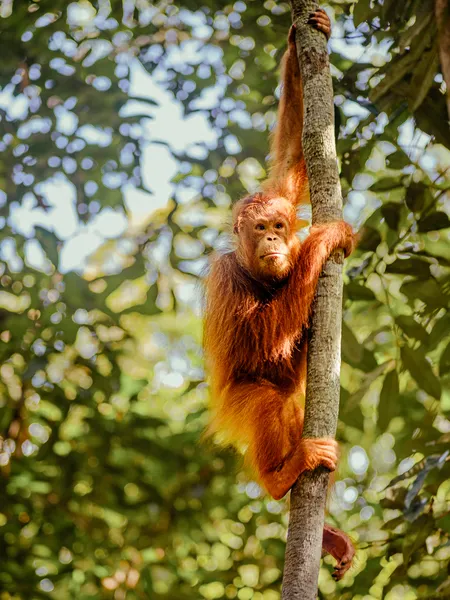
[{"left": 0, "top": 0, "right": 450, "bottom": 600}]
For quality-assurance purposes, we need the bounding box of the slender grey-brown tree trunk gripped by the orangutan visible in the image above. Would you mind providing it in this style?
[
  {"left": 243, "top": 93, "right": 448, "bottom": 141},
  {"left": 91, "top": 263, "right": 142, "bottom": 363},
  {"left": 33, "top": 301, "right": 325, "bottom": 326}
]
[{"left": 282, "top": 0, "right": 343, "bottom": 600}]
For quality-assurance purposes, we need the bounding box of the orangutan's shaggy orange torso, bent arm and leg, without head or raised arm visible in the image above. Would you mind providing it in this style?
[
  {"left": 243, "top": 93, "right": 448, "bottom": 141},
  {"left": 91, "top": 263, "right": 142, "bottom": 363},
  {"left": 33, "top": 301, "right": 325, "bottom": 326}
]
[{"left": 204, "top": 222, "right": 353, "bottom": 498}]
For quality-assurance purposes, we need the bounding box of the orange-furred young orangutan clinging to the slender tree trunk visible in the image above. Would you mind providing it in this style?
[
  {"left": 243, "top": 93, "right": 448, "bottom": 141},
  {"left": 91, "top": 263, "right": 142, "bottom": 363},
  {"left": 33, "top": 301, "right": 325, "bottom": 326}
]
[{"left": 204, "top": 11, "right": 354, "bottom": 576}]
